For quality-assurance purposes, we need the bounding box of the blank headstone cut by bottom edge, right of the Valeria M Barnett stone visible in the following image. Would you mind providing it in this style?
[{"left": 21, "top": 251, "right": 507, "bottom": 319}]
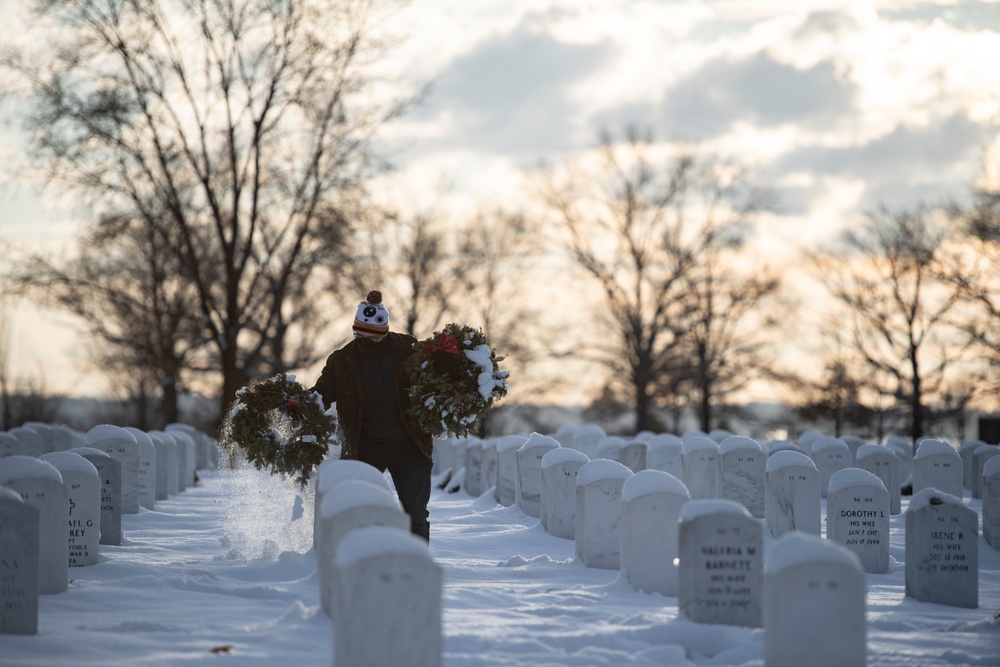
[{"left": 763, "top": 532, "right": 867, "bottom": 667}]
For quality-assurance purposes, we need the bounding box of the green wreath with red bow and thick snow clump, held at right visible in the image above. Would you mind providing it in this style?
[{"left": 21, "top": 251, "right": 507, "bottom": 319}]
[{"left": 406, "top": 324, "right": 509, "bottom": 437}]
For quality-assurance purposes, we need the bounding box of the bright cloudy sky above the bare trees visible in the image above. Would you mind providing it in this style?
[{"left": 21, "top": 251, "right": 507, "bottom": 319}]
[{"left": 0, "top": 0, "right": 1000, "bottom": 402}]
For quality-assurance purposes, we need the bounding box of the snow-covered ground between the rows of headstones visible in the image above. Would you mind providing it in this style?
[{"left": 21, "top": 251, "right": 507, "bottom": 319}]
[{"left": 0, "top": 460, "right": 1000, "bottom": 667}]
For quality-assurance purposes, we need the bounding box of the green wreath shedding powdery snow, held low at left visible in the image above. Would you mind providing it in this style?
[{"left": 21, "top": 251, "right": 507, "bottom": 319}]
[{"left": 222, "top": 373, "right": 337, "bottom": 486}]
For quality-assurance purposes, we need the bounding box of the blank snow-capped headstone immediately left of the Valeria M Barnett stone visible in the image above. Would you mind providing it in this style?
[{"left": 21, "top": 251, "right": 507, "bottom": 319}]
[{"left": 619, "top": 470, "right": 691, "bottom": 597}]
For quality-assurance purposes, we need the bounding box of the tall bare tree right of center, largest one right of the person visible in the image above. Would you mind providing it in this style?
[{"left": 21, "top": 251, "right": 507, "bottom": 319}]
[{"left": 543, "top": 129, "right": 760, "bottom": 430}]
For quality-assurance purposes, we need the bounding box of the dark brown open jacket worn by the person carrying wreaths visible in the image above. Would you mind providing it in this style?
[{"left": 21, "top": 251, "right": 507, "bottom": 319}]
[{"left": 313, "top": 331, "right": 434, "bottom": 459}]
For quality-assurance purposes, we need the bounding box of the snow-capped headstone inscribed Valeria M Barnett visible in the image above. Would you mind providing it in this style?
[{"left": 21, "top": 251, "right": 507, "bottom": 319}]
[{"left": 677, "top": 499, "right": 764, "bottom": 627}]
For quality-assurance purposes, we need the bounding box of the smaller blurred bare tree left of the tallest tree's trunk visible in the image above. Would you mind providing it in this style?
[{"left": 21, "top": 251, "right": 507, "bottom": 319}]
[{"left": 5, "top": 222, "right": 208, "bottom": 428}]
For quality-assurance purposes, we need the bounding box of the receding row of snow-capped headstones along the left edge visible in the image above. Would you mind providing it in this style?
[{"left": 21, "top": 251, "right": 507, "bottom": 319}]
[{"left": 0, "top": 424, "right": 215, "bottom": 634}]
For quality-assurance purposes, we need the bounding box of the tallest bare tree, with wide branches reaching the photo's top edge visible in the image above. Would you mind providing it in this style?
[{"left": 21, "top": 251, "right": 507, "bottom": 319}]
[{"left": 3, "top": 0, "right": 410, "bottom": 414}]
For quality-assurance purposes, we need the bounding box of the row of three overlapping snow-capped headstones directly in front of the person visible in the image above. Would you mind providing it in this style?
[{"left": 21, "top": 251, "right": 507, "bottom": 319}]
[{"left": 313, "top": 459, "right": 442, "bottom": 667}]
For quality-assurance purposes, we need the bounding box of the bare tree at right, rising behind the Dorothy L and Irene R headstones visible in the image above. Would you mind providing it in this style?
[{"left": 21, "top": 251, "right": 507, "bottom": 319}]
[{"left": 811, "top": 208, "right": 967, "bottom": 441}]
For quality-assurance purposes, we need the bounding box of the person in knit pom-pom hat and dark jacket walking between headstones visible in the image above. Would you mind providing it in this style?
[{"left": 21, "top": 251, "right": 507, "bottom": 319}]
[{"left": 312, "top": 290, "right": 434, "bottom": 541}]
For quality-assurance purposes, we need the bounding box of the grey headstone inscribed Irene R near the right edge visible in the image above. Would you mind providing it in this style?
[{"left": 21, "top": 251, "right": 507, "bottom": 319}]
[{"left": 905, "top": 489, "right": 979, "bottom": 609}]
